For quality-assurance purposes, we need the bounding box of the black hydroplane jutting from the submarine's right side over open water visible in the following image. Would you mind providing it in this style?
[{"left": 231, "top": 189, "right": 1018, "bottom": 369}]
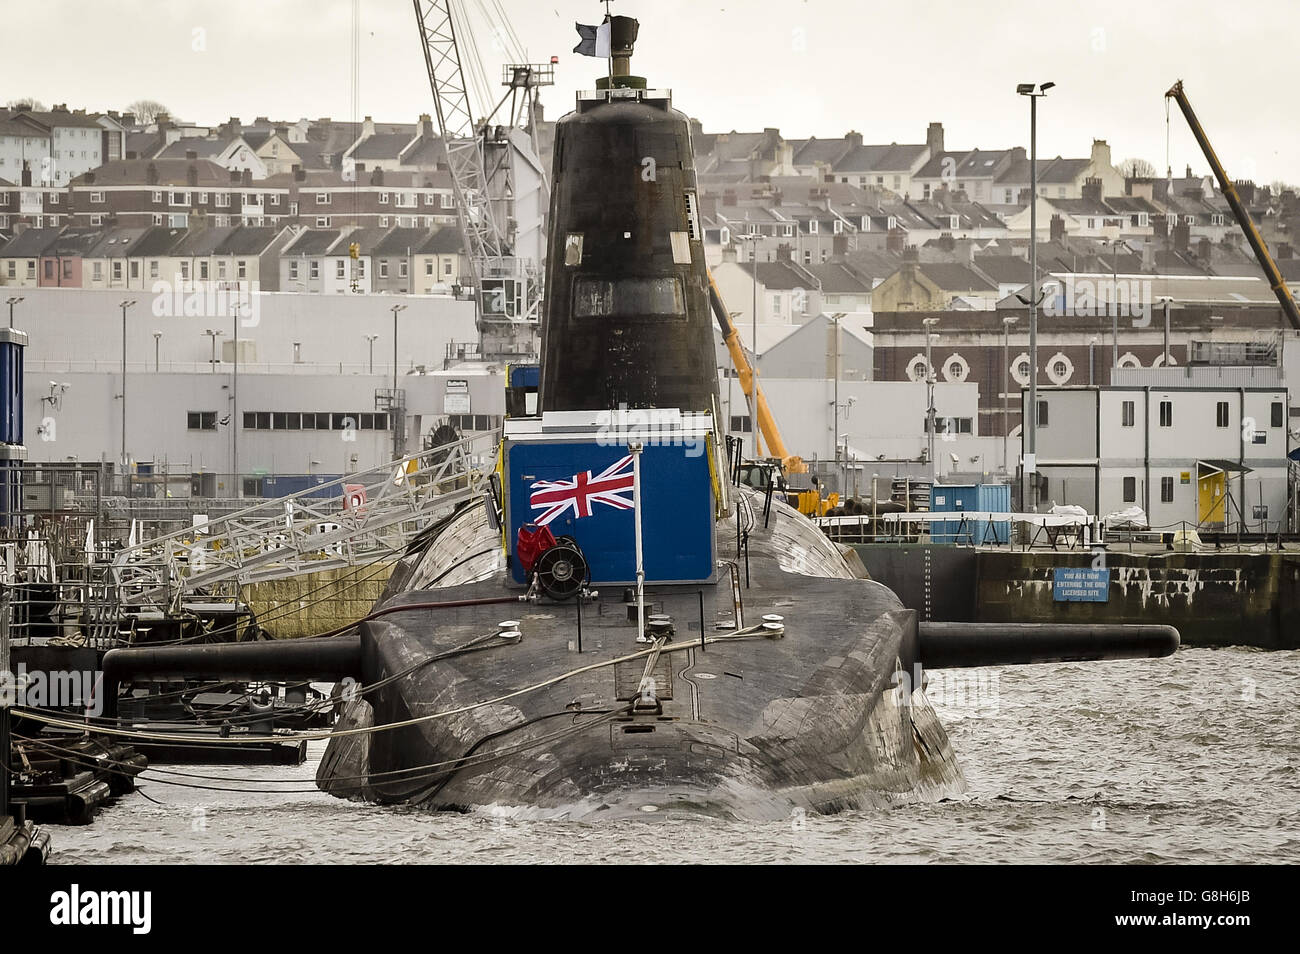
[{"left": 917, "top": 623, "right": 1179, "bottom": 669}]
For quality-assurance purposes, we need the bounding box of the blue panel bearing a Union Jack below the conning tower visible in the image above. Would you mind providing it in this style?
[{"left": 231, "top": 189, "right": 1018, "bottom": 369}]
[{"left": 506, "top": 441, "right": 714, "bottom": 584}]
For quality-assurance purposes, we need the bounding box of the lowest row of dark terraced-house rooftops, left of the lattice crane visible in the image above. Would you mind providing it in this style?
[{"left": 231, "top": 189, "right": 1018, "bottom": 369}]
[{"left": 0, "top": 225, "right": 462, "bottom": 259}]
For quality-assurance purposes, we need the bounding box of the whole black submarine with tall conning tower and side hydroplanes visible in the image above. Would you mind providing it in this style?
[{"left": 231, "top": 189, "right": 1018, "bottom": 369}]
[{"left": 94, "top": 16, "right": 1178, "bottom": 820}]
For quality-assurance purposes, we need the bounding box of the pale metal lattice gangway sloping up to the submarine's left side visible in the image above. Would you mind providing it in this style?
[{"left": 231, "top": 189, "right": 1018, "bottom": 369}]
[{"left": 96, "top": 433, "right": 497, "bottom": 620}]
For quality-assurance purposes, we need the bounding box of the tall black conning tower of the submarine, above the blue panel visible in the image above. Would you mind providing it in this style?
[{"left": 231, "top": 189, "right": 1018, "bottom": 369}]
[{"left": 538, "top": 17, "right": 718, "bottom": 413}]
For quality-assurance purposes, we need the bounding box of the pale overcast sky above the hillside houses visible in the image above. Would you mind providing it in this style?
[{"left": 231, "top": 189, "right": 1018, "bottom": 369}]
[{"left": 10, "top": 0, "right": 1300, "bottom": 183}]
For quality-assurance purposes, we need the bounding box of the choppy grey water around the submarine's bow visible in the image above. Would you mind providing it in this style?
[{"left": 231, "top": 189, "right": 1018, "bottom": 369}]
[{"left": 52, "top": 649, "right": 1300, "bottom": 863}]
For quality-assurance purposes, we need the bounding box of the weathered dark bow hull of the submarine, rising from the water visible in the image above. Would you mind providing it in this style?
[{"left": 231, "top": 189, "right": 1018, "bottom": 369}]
[{"left": 319, "top": 493, "right": 965, "bottom": 820}]
